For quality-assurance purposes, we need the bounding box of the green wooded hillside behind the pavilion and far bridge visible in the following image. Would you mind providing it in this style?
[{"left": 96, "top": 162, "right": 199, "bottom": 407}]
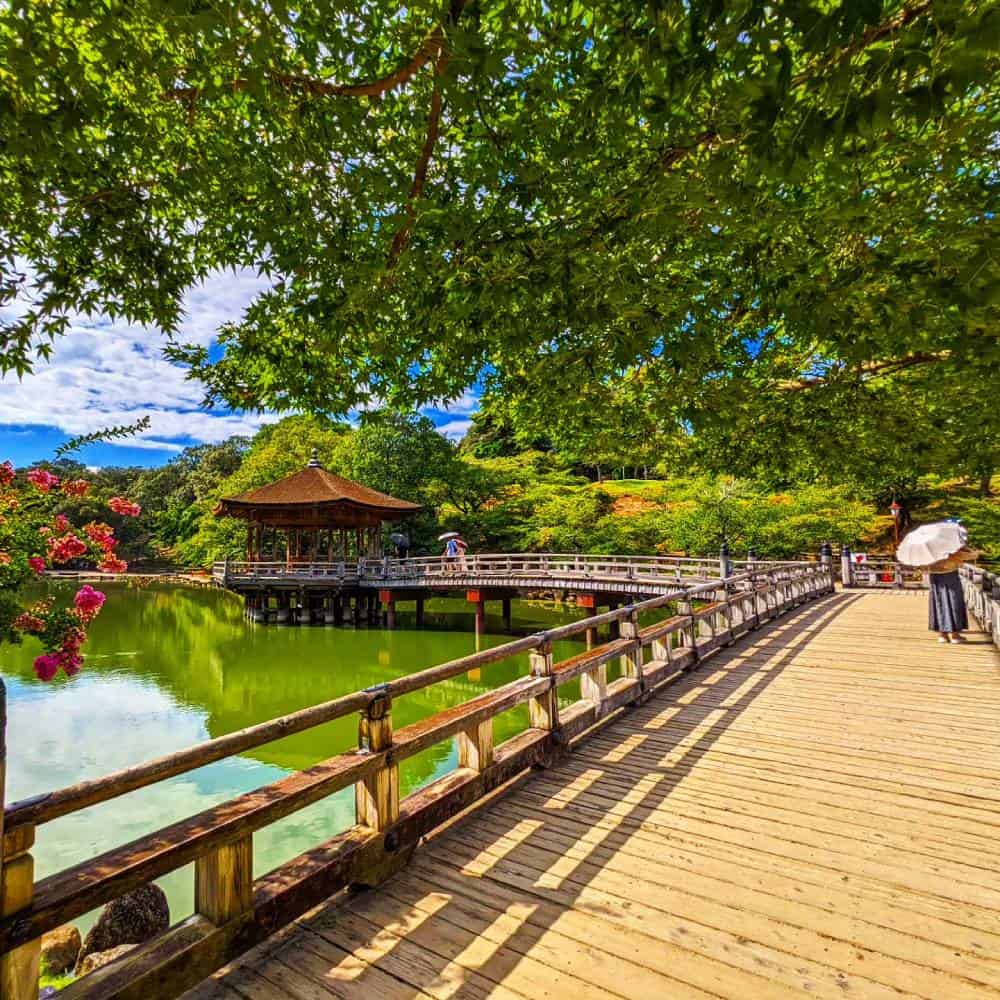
[{"left": 25, "top": 407, "right": 1000, "bottom": 568}]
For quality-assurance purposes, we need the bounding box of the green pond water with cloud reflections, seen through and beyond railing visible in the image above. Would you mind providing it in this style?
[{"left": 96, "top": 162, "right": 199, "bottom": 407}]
[{"left": 0, "top": 584, "right": 592, "bottom": 928}]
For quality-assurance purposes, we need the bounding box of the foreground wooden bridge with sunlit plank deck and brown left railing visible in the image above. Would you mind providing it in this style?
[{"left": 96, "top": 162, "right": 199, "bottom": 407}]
[{"left": 0, "top": 563, "right": 1000, "bottom": 1000}]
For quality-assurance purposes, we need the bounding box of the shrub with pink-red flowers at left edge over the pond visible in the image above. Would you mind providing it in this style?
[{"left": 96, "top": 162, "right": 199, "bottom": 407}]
[{"left": 0, "top": 461, "right": 142, "bottom": 681}]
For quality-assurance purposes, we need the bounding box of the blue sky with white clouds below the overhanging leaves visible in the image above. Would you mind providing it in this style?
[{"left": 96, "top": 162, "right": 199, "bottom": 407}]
[{"left": 0, "top": 271, "right": 477, "bottom": 466}]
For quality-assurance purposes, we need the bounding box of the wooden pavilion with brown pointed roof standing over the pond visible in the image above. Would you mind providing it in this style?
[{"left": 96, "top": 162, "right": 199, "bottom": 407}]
[{"left": 215, "top": 449, "right": 421, "bottom": 562}]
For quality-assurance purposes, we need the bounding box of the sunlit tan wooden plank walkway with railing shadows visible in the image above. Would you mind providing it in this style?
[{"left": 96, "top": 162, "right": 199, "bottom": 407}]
[{"left": 188, "top": 592, "right": 1000, "bottom": 1000}]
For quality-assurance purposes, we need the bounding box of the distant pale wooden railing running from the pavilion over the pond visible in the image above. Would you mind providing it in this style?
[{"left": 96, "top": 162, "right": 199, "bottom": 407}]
[{"left": 212, "top": 552, "right": 798, "bottom": 588}]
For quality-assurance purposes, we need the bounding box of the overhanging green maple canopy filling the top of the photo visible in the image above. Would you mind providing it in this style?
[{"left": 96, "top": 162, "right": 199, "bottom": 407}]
[{"left": 0, "top": 0, "right": 1000, "bottom": 446}]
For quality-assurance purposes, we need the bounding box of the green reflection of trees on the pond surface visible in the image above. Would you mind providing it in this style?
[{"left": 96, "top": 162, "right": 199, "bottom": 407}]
[{"left": 5, "top": 584, "right": 576, "bottom": 789}]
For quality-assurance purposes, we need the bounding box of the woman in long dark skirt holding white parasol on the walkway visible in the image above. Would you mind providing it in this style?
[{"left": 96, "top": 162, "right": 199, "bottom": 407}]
[{"left": 896, "top": 521, "right": 978, "bottom": 643}]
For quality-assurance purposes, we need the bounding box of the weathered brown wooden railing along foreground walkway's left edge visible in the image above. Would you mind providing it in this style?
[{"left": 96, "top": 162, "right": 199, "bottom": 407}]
[{"left": 0, "top": 561, "right": 834, "bottom": 1000}]
